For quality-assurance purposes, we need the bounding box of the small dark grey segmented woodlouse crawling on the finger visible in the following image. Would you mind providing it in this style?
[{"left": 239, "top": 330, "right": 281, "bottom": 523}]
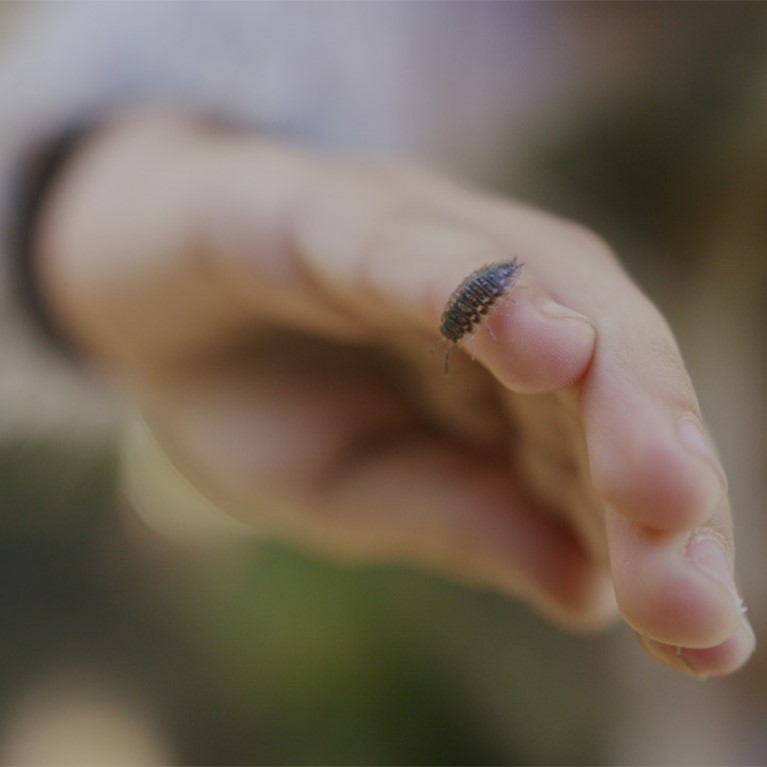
[{"left": 439, "top": 258, "right": 522, "bottom": 373}]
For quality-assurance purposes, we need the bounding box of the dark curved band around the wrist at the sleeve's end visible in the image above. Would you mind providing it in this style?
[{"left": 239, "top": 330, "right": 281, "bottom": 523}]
[{"left": 9, "top": 128, "right": 91, "bottom": 358}]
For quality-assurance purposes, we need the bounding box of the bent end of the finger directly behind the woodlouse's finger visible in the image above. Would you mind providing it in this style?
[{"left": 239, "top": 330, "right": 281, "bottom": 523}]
[{"left": 581, "top": 318, "right": 726, "bottom": 531}]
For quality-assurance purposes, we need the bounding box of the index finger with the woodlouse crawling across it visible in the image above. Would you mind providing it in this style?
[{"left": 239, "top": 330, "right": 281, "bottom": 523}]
[{"left": 297, "top": 183, "right": 595, "bottom": 393}]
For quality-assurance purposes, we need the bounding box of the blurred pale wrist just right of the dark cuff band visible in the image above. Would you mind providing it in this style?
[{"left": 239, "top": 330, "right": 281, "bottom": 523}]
[{"left": 29, "top": 114, "right": 222, "bottom": 366}]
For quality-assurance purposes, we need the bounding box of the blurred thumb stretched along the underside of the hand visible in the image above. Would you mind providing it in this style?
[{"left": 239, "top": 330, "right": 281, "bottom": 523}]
[{"left": 150, "top": 360, "right": 615, "bottom": 628}]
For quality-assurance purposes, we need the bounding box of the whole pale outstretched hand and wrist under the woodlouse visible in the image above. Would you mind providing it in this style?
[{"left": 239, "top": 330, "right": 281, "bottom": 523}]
[{"left": 37, "top": 115, "right": 754, "bottom": 676}]
